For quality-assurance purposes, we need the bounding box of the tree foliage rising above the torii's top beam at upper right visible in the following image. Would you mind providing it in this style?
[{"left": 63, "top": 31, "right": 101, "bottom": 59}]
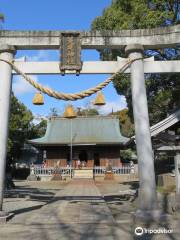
[{"left": 92, "top": 0, "right": 180, "bottom": 30}]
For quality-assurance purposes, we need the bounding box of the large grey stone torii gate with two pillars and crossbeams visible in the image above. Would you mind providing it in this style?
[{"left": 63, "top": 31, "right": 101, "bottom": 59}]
[{"left": 0, "top": 25, "right": 180, "bottom": 218}]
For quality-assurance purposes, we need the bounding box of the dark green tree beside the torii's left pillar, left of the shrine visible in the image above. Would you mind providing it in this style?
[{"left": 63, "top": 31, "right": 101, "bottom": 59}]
[{"left": 8, "top": 93, "right": 46, "bottom": 161}]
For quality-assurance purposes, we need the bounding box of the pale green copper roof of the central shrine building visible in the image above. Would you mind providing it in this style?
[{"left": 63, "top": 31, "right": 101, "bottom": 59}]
[{"left": 29, "top": 116, "right": 129, "bottom": 145}]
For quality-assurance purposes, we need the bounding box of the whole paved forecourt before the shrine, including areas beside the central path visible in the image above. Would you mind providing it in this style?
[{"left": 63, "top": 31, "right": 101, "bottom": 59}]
[{"left": 0, "top": 180, "right": 180, "bottom": 240}]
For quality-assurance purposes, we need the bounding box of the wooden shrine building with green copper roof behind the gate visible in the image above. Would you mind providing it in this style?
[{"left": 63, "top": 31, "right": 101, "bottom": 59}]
[{"left": 29, "top": 116, "right": 129, "bottom": 167}]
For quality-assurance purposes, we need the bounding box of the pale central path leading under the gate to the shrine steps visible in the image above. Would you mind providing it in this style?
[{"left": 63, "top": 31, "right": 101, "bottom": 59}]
[{"left": 0, "top": 180, "right": 132, "bottom": 240}]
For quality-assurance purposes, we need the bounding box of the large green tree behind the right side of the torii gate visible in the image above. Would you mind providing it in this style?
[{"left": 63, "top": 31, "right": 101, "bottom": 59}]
[{"left": 92, "top": 0, "right": 180, "bottom": 124}]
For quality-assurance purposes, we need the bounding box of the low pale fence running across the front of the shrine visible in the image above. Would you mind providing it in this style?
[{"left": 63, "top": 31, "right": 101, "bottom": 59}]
[{"left": 31, "top": 164, "right": 133, "bottom": 176}]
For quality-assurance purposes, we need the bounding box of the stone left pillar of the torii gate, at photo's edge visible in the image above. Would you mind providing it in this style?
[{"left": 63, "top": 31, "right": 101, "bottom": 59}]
[{"left": 0, "top": 45, "right": 15, "bottom": 216}]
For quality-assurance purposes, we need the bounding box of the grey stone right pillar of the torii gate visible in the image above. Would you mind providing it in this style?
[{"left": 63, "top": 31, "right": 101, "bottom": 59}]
[{"left": 125, "top": 44, "right": 157, "bottom": 218}]
